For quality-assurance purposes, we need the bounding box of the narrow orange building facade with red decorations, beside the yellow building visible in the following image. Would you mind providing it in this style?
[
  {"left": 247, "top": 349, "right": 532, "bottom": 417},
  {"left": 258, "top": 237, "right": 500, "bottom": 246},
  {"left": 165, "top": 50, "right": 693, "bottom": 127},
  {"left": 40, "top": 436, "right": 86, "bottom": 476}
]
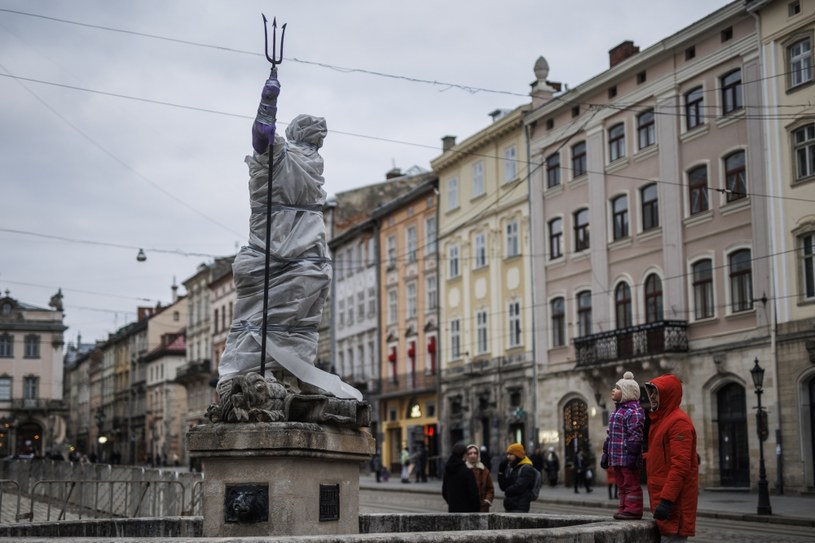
[{"left": 372, "top": 174, "right": 441, "bottom": 477}]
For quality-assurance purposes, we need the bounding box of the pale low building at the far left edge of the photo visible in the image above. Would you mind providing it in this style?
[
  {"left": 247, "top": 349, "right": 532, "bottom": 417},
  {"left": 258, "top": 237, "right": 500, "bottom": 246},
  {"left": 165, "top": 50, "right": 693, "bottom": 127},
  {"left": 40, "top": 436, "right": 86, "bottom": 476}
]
[{"left": 0, "top": 290, "right": 68, "bottom": 457}]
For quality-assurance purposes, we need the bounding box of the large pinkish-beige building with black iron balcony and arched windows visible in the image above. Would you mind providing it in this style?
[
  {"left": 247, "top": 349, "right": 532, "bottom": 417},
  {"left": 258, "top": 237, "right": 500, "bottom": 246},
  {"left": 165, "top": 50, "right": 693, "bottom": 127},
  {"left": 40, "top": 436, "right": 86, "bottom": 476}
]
[{"left": 525, "top": 2, "right": 779, "bottom": 487}]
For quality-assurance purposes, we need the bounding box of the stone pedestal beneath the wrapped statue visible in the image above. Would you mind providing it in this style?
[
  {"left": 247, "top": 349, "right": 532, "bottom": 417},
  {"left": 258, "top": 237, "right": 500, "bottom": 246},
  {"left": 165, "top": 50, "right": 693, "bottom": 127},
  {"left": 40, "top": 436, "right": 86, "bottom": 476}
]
[{"left": 187, "top": 422, "right": 375, "bottom": 537}]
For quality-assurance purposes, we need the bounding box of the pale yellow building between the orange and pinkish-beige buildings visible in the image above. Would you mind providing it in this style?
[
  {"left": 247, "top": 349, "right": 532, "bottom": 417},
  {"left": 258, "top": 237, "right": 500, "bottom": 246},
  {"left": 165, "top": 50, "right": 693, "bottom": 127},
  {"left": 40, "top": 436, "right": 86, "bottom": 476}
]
[{"left": 431, "top": 102, "right": 540, "bottom": 464}]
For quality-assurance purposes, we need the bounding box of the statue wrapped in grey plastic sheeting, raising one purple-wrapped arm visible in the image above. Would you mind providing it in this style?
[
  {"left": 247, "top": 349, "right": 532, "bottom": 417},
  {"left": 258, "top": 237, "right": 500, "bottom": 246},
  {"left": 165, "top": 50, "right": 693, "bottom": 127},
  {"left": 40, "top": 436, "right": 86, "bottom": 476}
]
[{"left": 209, "top": 67, "right": 362, "bottom": 428}]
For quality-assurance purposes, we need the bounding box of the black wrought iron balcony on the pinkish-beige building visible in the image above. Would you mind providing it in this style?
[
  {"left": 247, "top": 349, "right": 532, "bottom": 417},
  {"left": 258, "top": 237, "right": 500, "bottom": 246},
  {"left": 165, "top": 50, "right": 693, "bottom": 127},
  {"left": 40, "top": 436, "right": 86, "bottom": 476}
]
[{"left": 574, "top": 321, "right": 688, "bottom": 367}]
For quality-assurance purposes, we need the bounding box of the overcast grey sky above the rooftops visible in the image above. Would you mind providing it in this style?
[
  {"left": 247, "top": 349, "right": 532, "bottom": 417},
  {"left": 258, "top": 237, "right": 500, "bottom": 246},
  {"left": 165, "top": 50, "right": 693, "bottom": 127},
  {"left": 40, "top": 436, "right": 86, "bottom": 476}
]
[{"left": 0, "top": 0, "right": 728, "bottom": 342}]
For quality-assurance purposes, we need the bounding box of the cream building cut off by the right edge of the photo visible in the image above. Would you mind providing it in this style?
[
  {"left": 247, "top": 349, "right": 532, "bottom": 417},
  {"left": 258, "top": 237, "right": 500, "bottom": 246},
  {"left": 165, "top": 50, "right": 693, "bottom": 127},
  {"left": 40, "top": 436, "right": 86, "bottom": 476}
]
[{"left": 747, "top": 0, "right": 815, "bottom": 492}]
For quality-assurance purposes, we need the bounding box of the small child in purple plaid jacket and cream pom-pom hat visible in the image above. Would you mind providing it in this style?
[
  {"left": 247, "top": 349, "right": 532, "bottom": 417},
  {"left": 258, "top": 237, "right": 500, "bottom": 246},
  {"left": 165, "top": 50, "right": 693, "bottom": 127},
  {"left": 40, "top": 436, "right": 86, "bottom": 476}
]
[{"left": 600, "top": 371, "right": 645, "bottom": 520}]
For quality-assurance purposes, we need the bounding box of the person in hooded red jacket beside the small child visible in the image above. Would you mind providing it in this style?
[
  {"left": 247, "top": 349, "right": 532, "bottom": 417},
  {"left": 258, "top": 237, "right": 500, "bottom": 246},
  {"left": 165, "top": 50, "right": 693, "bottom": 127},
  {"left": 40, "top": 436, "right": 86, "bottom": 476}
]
[{"left": 644, "top": 374, "right": 699, "bottom": 543}]
